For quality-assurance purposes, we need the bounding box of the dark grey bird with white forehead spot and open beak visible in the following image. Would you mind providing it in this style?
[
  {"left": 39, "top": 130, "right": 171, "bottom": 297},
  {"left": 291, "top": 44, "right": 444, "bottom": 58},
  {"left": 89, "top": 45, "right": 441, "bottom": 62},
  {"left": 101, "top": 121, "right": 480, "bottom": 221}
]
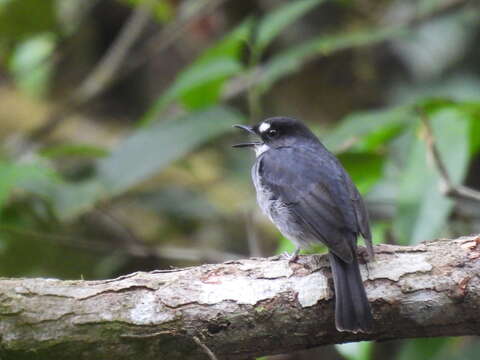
[{"left": 233, "top": 117, "right": 374, "bottom": 333}]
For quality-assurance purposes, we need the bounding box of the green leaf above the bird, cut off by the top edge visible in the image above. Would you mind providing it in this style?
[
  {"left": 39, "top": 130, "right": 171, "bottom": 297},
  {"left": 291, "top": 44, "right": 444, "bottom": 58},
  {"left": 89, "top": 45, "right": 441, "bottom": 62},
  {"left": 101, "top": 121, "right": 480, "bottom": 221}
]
[{"left": 255, "top": 0, "right": 324, "bottom": 51}]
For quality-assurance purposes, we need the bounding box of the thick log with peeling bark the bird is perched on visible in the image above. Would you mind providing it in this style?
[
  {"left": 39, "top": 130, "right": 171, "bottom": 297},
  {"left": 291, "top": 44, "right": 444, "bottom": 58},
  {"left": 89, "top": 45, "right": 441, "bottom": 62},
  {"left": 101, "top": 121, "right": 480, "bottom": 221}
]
[{"left": 0, "top": 236, "right": 480, "bottom": 360}]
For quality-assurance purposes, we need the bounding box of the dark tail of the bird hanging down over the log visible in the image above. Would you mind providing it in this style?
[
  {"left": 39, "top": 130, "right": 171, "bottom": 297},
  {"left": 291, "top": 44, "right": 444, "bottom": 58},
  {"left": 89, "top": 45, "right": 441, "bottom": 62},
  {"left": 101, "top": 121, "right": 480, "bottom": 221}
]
[{"left": 329, "top": 252, "right": 373, "bottom": 332}]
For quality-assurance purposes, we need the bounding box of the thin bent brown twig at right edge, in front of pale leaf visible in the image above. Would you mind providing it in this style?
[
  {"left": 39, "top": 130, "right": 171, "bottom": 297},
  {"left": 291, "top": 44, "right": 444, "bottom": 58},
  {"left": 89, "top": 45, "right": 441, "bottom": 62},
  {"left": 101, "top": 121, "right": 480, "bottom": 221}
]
[{"left": 417, "top": 107, "right": 480, "bottom": 201}]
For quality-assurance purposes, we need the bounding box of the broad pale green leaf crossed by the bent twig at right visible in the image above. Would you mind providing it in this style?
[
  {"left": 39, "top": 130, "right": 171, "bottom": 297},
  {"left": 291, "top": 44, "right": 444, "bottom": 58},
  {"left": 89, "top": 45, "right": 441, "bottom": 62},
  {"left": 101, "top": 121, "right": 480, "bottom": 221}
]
[{"left": 394, "top": 107, "right": 469, "bottom": 244}]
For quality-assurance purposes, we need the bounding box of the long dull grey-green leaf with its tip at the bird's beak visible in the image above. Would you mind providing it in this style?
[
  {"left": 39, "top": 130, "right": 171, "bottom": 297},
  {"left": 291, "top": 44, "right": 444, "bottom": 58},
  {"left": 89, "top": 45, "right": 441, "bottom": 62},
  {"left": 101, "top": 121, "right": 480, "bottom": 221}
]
[{"left": 42, "top": 107, "right": 243, "bottom": 219}]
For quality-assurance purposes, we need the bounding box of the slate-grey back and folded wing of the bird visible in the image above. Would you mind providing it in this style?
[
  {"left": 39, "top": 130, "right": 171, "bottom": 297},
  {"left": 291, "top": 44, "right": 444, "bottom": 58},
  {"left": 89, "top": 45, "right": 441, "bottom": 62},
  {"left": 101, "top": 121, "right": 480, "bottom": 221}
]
[{"left": 259, "top": 147, "right": 369, "bottom": 262}]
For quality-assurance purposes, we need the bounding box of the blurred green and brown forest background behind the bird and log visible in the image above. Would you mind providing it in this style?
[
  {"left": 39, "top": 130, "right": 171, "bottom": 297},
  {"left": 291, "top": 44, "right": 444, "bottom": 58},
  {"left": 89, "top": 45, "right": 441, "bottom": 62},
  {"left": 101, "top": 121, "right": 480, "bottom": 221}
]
[{"left": 0, "top": 0, "right": 480, "bottom": 360}]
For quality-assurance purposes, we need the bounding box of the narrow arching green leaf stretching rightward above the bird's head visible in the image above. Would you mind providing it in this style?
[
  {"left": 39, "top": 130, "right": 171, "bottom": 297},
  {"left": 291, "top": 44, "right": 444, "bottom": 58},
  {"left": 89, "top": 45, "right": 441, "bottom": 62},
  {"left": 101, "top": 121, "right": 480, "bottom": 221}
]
[{"left": 258, "top": 27, "right": 406, "bottom": 93}]
